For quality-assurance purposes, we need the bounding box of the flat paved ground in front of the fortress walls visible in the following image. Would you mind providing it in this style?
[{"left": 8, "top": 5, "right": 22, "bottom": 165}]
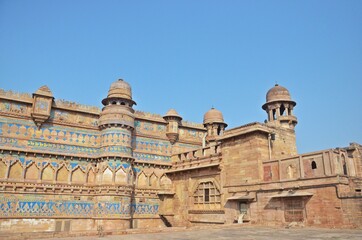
[{"left": 36, "top": 226, "right": 362, "bottom": 240}]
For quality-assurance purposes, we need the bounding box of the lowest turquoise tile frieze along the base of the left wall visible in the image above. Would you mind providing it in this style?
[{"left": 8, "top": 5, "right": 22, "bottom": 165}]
[{"left": 0, "top": 194, "right": 159, "bottom": 218}]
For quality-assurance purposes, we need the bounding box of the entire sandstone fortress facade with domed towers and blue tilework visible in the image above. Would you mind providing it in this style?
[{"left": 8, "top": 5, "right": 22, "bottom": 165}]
[{"left": 0, "top": 80, "right": 362, "bottom": 233}]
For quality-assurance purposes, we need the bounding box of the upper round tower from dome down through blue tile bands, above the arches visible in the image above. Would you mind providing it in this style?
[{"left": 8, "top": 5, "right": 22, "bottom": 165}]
[{"left": 98, "top": 79, "right": 136, "bottom": 158}]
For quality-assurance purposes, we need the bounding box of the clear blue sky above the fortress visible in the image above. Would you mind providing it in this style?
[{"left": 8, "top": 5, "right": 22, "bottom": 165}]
[{"left": 0, "top": 0, "right": 362, "bottom": 153}]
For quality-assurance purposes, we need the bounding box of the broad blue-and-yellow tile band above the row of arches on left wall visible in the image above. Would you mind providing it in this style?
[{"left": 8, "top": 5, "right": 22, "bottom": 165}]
[{"left": 0, "top": 118, "right": 175, "bottom": 162}]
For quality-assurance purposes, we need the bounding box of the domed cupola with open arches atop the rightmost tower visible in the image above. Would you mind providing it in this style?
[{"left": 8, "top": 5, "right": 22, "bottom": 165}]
[{"left": 262, "top": 84, "right": 298, "bottom": 128}]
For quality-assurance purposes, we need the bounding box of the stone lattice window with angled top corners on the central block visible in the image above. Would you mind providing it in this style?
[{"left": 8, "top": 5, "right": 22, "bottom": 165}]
[{"left": 194, "top": 181, "right": 220, "bottom": 204}]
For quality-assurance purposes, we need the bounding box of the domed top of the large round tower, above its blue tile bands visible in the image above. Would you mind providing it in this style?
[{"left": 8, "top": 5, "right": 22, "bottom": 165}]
[{"left": 98, "top": 79, "right": 136, "bottom": 129}]
